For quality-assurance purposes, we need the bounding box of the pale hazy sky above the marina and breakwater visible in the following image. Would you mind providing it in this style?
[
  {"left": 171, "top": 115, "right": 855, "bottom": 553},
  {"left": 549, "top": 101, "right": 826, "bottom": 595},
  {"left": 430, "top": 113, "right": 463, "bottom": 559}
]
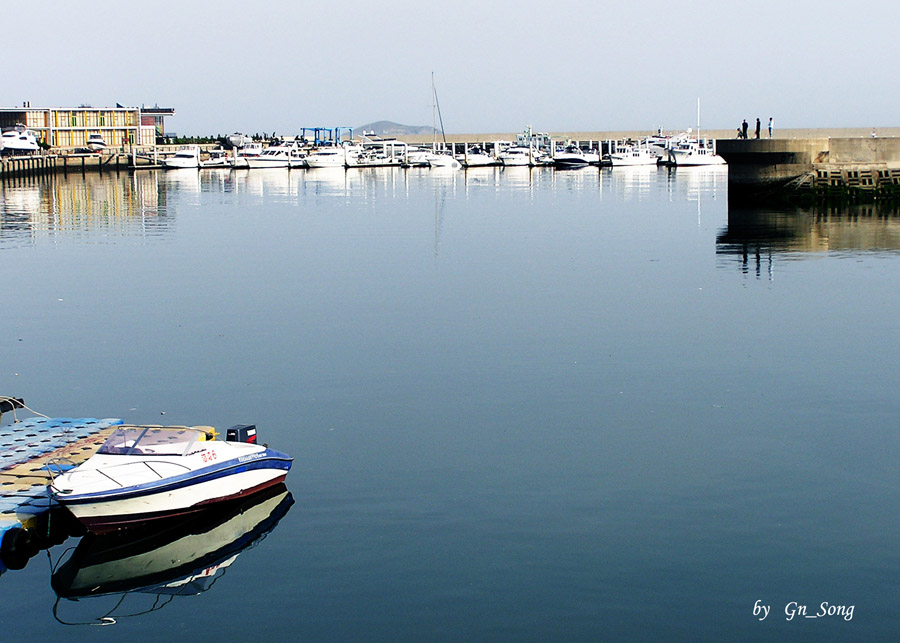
[{"left": 8, "top": 0, "right": 900, "bottom": 134}]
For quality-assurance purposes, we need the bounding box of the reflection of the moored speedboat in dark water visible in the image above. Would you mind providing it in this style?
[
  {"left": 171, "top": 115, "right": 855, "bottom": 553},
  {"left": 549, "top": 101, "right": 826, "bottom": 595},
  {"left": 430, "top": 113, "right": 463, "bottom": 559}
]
[{"left": 50, "top": 484, "right": 294, "bottom": 625}]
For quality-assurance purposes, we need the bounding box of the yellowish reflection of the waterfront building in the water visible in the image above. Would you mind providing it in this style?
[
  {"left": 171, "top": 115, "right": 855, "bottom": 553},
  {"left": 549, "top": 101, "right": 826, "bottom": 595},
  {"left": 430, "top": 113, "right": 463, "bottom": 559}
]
[{"left": 0, "top": 172, "right": 172, "bottom": 249}]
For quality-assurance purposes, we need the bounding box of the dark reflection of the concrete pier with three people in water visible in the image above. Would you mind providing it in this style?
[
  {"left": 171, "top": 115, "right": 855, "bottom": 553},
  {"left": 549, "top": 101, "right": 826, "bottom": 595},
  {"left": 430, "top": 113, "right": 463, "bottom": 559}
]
[{"left": 716, "top": 197, "right": 900, "bottom": 277}]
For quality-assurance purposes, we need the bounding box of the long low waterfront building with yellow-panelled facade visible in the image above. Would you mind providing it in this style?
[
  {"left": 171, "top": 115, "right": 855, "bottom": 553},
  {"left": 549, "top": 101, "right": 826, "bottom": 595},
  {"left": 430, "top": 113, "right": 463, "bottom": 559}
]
[{"left": 0, "top": 102, "right": 175, "bottom": 148}]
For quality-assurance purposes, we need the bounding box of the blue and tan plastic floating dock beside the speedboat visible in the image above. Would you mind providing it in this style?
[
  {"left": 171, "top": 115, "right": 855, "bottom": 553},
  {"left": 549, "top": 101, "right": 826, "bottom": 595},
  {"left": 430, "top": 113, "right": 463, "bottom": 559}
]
[{"left": 0, "top": 417, "right": 122, "bottom": 573}]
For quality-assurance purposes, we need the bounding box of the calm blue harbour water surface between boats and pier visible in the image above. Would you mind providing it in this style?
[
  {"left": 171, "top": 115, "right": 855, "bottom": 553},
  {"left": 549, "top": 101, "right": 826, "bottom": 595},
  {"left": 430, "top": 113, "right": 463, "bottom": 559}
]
[{"left": 0, "top": 168, "right": 900, "bottom": 641}]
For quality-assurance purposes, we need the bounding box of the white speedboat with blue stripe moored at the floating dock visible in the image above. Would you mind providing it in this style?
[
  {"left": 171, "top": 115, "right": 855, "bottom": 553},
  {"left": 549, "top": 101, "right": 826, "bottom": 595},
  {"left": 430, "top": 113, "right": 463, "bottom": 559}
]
[{"left": 50, "top": 426, "right": 292, "bottom": 533}]
